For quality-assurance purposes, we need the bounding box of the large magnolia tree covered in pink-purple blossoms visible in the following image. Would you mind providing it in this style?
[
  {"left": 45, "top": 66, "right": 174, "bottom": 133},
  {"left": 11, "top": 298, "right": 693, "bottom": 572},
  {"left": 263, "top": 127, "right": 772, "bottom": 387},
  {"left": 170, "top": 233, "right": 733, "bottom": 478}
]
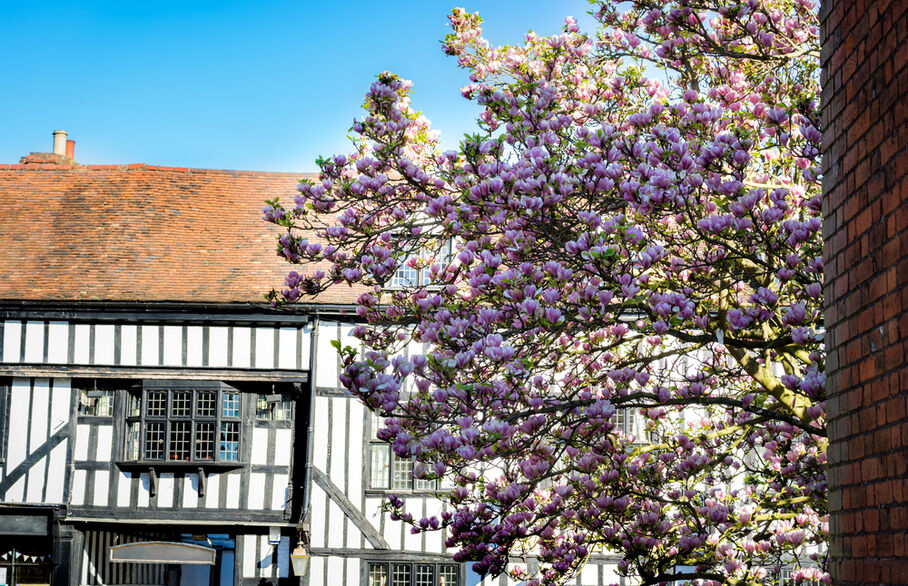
[{"left": 265, "top": 0, "right": 828, "bottom": 584}]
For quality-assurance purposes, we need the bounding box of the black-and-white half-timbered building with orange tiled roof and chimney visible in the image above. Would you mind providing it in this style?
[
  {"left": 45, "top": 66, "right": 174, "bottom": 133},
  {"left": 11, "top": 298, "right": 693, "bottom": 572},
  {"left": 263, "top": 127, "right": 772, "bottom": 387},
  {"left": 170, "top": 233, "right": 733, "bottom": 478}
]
[{"left": 0, "top": 135, "right": 632, "bottom": 586}]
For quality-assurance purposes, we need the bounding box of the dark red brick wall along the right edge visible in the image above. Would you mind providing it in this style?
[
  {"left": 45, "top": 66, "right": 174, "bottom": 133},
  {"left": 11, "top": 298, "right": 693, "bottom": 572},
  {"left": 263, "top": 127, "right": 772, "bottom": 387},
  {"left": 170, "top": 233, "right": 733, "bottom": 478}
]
[{"left": 820, "top": 0, "right": 908, "bottom": 584}]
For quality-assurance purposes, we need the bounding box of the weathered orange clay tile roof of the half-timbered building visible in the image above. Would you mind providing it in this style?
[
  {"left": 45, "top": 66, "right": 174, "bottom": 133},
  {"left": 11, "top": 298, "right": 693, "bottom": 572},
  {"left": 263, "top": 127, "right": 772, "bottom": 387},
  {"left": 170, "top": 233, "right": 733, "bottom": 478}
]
[{"left": 0, "top": 164, "right": 356, "bottom": 304}]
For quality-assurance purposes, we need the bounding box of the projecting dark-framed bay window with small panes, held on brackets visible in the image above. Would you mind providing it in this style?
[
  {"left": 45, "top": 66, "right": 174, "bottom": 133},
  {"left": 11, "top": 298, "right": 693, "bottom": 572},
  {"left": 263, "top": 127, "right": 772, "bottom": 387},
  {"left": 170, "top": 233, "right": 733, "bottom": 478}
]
[{"left": 123, "top": 380, "right": 244, "bottom": 466}]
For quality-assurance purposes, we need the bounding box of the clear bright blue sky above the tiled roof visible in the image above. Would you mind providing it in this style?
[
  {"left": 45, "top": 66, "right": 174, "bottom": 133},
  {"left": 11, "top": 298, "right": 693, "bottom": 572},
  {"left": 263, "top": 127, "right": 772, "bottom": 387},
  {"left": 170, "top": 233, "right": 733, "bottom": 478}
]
[{"left": 0, "top": 0, "right": 593, "bottom": 171}]
